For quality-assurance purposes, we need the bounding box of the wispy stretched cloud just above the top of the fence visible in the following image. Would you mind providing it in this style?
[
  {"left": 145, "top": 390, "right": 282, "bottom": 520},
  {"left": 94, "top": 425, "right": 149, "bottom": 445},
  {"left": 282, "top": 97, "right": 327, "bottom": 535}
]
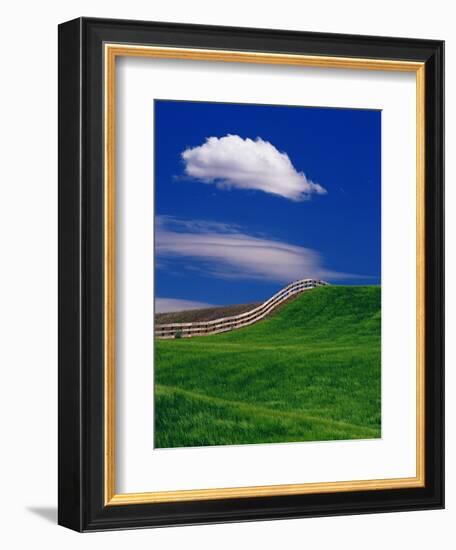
[{"left": 156, "top": 216, "right": 357, "bottom": 283}]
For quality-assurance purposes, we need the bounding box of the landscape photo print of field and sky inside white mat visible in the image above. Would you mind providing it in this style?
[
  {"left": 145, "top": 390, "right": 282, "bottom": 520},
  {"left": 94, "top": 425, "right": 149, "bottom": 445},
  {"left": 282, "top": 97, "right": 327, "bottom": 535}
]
[{"left": 151, "top": 100, "right": 381, "bottom": 448}]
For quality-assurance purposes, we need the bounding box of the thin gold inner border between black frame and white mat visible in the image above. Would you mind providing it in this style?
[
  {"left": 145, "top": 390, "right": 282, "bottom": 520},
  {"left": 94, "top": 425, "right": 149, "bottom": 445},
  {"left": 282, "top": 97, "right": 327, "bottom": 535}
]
[{"left": 103, "top": 44, "right": 425, "bottom": 506}]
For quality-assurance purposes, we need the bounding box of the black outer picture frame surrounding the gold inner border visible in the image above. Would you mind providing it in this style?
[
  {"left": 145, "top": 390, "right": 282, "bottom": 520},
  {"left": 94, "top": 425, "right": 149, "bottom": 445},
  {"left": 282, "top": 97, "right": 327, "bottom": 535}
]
[{"left": 58, "top": 18, "right": 444, "bottom": 531}]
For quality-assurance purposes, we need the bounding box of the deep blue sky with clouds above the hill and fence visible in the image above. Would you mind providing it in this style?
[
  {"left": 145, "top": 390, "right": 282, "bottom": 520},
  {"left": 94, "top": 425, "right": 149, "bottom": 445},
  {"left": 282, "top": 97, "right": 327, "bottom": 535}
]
[{"left": 154, "top": 100, "right": 381, "bottom": 311}]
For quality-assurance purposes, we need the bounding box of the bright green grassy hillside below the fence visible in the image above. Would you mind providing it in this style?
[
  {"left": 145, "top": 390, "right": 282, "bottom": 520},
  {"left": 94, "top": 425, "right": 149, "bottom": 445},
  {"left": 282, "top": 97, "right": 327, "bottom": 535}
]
[{"left": 155, "top": 286, "right": 381, "bottom": 448}]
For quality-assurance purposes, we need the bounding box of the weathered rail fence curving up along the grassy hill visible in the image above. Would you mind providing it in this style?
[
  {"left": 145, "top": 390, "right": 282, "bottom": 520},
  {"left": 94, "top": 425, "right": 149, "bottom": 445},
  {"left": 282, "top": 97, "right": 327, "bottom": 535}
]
[{"left": 155, "top": 279, "right": 328, "bottom": 339}]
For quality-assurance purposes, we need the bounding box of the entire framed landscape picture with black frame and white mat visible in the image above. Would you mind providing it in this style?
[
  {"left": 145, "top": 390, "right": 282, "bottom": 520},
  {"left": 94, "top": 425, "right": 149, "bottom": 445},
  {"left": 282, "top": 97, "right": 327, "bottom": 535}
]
[{"left": 59, "top": 18, "right": 444, "bottom": 531}]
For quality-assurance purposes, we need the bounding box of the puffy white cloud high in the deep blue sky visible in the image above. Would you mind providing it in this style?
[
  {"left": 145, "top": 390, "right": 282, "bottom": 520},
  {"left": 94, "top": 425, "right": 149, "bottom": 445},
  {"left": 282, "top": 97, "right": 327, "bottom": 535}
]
[{"left": 182, "top": 134, "right": 326, "bottom": 201}]
